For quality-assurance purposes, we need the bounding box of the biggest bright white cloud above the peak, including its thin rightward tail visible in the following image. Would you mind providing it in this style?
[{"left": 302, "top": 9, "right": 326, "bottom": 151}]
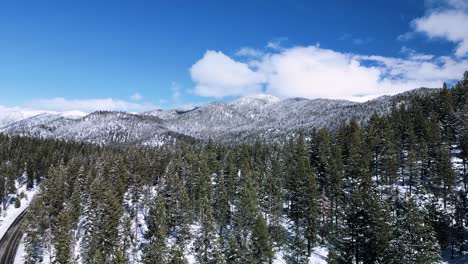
[{"left": 261, "top": 46, "right": 441, "bottom": 101}]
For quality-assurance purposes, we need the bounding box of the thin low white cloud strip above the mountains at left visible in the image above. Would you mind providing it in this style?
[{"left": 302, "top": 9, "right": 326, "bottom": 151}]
[{"left": 28, "top": 97, "right": 156, "bottom": 112}]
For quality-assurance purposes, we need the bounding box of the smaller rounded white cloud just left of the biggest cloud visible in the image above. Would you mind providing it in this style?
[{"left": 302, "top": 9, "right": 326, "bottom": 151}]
[{"left": 190, "top": 51, "right": 263, "bottom": 97}]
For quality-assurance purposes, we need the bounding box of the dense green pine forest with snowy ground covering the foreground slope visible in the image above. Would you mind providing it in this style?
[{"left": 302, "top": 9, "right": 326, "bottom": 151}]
[{"left": 0, "top": 72, "right": 468, "bottom": 264}]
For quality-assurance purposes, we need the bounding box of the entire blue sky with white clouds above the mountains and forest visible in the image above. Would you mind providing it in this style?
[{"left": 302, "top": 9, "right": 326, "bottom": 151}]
[{"left": 0, "top": 0, "right": 468, "bottom": 112}]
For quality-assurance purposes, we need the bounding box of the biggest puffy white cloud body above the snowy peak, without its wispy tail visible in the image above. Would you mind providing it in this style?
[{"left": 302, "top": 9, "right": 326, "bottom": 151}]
[{"left": 260, "top": 46, "right": 379, "bottom": 99}]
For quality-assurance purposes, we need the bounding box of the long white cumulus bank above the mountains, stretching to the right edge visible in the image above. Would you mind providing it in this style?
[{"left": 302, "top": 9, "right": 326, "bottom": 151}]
[{"left": 191, "top": 46, "right": 468, "bottom": 101}]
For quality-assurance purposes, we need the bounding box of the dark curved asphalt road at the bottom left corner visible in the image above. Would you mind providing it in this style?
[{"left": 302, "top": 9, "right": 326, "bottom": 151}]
[{"left": 0, "top": 210, "right": 26, "bottom": 264}]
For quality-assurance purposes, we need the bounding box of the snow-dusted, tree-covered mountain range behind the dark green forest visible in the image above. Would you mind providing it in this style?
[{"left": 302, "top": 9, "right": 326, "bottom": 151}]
[{"left": 0, "top": 88, "right": 434, "bottom": 146}]
